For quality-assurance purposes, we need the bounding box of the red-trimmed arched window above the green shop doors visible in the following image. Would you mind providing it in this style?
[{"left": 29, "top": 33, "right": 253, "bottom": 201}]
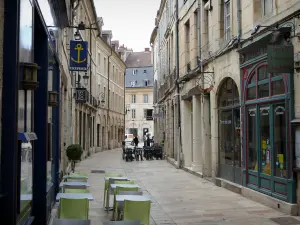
[{"left": 246, "top": 64, "right": 286, "bottom": 101}]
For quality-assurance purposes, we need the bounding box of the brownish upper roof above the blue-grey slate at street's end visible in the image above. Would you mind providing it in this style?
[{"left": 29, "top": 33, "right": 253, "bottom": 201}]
[{"left": 125, "top": 51, "right": 152, "bottom": 68}]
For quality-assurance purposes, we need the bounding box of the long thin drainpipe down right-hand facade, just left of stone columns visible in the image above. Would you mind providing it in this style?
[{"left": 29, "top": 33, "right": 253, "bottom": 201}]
[{"left": 176, "top": 0, "right": 182, "bottom": 168}]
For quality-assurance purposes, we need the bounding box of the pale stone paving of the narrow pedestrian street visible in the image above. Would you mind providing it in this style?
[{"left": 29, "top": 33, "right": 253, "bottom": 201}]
[{"left": 76, "top": 149, "right": 300, "bottom": 225}]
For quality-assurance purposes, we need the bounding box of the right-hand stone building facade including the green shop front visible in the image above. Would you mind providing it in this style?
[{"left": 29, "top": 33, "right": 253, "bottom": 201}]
[{"left": 151, "top": 0, "right": 300, "bottom": 215}]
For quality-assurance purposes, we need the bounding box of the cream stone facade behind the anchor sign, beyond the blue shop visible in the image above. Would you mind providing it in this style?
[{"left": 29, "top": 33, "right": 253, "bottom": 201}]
[{"left": 73, "top": 1, "right": 126, "bottom": 155}]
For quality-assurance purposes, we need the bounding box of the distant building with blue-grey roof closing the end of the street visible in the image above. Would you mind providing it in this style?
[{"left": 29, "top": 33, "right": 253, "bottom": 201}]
[{"left": 125, "top": 48, "right": 154, "bottom": 140}]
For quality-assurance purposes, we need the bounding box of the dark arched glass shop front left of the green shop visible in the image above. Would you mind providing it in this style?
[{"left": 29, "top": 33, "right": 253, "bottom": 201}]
[{"left": 219, "top": 77, "right": 242, "bottom": 184}]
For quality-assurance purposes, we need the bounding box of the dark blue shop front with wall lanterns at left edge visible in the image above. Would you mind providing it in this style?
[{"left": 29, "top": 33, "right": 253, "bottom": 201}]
[{"left": 0, "top": 0, "right": 68, "bottom": 225}]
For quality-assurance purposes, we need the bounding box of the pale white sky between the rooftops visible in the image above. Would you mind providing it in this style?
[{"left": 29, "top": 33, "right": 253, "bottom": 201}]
[{"left": 94, "top": 0, "right": 161, "bottom": 52}]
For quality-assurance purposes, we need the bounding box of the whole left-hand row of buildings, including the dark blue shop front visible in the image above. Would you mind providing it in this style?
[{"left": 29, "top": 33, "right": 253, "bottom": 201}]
[{"left": 0, "top": 0, "right": 126, "bottom": 225}]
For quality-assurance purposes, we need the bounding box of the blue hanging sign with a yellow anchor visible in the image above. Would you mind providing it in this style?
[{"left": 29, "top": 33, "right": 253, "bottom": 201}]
[{"left": 70, "top": 40, "right": 88, "bottom": 71}]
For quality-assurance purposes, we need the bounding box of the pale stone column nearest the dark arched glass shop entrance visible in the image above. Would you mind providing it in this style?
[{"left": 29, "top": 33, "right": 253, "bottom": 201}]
[{"left": 201, "top": 96, "right": 212, "bottom": 177}]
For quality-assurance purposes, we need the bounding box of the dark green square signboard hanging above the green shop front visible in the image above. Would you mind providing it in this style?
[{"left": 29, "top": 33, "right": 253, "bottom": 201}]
[{"left": 267, "top": 45, "right": 294, "bottom": 73}]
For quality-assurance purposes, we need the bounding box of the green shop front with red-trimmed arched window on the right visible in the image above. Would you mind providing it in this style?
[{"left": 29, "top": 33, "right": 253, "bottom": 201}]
[{"left": 240, "top": 27, "right": 296, "bottom": 203}]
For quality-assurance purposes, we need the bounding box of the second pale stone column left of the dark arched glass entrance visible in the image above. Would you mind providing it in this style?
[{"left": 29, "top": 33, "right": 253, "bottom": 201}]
[{"left": 192, "top": 95, "right": 203, "bottom": 172}]
